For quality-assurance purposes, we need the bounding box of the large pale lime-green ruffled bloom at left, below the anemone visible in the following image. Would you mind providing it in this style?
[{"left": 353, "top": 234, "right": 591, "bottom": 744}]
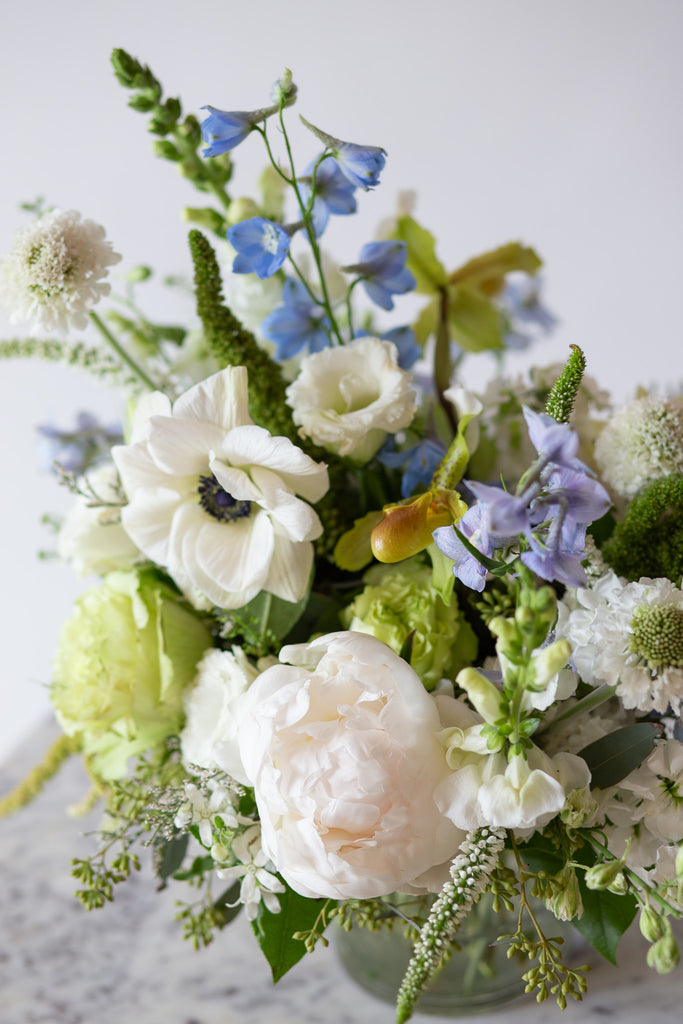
[{"left": 51, "top": 572, "right": 211, "bottom": 778}]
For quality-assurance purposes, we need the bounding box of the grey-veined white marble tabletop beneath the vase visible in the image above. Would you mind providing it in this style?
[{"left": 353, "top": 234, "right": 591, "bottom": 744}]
[{"left": 0, "top": 724, "right": 683, "bottom": 1024}]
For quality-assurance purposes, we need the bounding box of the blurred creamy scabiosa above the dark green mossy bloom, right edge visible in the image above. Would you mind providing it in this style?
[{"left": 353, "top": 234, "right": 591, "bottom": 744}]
[{"left": 595, "top": 395, "right": 683, "bottom": 498}]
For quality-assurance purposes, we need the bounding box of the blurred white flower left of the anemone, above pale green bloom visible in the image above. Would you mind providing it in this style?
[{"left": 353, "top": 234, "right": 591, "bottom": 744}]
[{"left": 57, "top": 462, "right": 140, "bottom": 577}]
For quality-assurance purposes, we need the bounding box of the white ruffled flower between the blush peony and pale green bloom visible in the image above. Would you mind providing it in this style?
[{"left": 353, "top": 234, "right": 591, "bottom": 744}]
[{"left": 180, "top": 647, "right": 258, "bottom": 784}]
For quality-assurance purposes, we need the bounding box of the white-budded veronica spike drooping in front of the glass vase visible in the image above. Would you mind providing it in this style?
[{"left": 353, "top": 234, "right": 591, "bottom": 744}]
[{"left": 396, "top": 827, "right": 505, "bottom": 1024}]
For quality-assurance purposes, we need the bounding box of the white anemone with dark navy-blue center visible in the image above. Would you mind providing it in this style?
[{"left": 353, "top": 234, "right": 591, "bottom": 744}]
[{"left": 112, "top": 367, "right": 329, "bottom": 608}]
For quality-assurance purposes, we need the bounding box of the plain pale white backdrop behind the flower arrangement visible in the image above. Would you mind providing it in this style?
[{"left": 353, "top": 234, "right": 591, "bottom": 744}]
[{"left": 0, "top": 0, "right": 683, "bottom": 755}]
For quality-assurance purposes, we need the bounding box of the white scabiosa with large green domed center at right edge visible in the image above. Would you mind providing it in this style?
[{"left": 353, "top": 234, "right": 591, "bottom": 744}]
[{"left": 556, "top": 572, "right": 683, "bottom": 715}]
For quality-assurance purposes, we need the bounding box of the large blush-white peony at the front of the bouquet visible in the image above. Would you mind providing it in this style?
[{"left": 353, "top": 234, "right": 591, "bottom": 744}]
[{"left": 239, "top": 632, "right": 463, "bottom": 899}]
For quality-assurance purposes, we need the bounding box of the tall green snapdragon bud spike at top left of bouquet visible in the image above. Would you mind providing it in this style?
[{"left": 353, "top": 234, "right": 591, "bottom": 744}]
[{"left": 112, "top": 49, "right": 232, "bottom": 238}]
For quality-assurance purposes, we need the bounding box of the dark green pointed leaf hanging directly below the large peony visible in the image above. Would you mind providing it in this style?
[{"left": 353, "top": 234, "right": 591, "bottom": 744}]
[{"left": 252, "top": 886, "right": 334, "bottom": 983}]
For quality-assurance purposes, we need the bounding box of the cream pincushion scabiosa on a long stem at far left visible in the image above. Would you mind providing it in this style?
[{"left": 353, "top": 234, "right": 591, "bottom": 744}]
[{"left": 0, "top": 210, "right": 121, "bottom": 332}]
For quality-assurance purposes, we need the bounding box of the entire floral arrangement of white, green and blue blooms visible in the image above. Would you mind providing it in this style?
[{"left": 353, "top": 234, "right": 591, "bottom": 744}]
[{"left": 0, "top": 50, "right": 683, "bottom": 1021}]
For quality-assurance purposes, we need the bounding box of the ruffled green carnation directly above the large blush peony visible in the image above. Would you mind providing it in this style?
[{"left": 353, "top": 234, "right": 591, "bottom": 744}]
[{"left": 341, "top": 562, "right": 477, "bottom": 690}]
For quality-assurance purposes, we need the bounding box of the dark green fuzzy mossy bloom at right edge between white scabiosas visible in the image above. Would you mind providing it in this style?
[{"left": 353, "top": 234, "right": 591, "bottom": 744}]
[{"left": 602, "top": 473, "right": 683, "bottom": 586}]
